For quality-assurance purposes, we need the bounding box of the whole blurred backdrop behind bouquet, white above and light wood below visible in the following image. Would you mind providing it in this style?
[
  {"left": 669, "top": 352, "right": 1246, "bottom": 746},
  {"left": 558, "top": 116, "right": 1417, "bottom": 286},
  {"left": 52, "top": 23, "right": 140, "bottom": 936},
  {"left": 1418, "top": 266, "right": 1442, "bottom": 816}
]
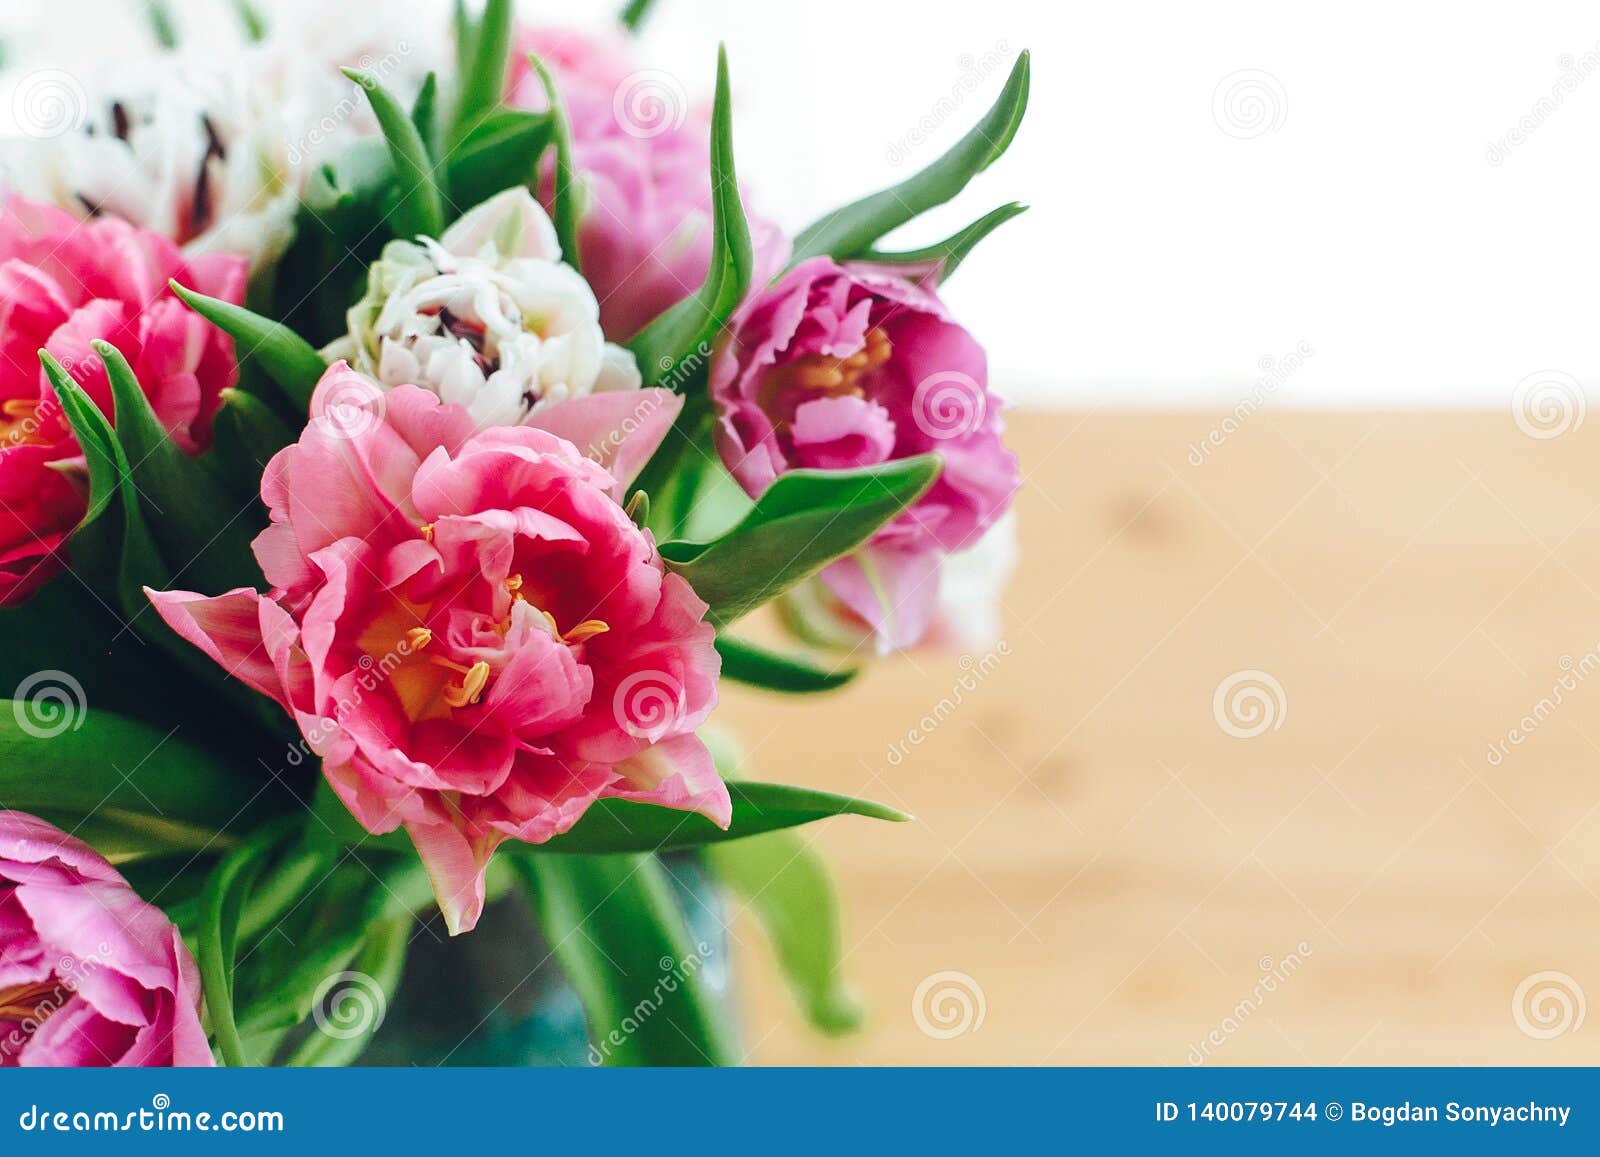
[{"left": 0, "top": 0, "right": 1600, "bottom": 1064}]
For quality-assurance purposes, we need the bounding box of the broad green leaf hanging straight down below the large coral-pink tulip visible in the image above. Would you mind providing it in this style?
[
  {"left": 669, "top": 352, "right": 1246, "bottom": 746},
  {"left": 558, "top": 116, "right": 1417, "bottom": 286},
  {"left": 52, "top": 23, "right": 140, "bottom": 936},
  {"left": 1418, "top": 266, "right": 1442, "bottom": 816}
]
[{"left": 514, "top": 856, "right": 738, "bottom": 1066}]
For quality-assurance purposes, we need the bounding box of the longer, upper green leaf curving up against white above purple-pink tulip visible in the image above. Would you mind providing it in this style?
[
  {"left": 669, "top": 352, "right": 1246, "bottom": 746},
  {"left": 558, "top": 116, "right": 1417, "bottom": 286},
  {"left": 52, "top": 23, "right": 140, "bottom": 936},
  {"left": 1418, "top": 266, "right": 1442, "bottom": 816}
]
[{"left": 794, "top": 51, "right": 1029, "bottom": 264}]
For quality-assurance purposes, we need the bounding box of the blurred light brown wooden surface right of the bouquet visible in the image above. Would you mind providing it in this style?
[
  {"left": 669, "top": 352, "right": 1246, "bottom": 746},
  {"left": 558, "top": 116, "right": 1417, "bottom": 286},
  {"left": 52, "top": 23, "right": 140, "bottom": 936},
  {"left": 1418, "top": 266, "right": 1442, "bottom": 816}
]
[{"left": 718, "top": 413, "right": 1600, "bottom": 1064}]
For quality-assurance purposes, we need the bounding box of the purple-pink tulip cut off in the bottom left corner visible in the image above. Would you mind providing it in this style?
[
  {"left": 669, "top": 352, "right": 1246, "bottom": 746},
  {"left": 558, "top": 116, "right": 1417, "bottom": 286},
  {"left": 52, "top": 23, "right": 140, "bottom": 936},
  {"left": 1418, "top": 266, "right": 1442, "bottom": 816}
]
[{"left": 0, "top": 811, "right": 213, "bottom": 1067}]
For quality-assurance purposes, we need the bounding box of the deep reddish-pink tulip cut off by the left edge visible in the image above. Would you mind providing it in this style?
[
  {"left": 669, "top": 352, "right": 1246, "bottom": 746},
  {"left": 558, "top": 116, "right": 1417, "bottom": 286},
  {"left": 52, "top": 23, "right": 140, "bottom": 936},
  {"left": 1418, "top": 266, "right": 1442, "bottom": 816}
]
[{"left": 0, "top": 197, "right": 245, "bottom": 605}]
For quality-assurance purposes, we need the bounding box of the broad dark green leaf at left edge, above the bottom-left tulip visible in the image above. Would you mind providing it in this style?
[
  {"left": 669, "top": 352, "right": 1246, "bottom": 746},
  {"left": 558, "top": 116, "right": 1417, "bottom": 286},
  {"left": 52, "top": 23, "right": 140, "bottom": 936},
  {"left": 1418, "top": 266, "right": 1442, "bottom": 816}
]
[{"left": 0, "top": 707, "right": 286, "bottom": 850}]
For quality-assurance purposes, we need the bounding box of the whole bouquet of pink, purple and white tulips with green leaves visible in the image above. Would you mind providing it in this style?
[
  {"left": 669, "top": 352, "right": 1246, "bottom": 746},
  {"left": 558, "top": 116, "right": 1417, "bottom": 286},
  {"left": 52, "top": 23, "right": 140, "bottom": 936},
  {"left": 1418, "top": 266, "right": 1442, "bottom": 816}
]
[{"left": 0, "top": 0, "right": 1029, "bottom": 1066}]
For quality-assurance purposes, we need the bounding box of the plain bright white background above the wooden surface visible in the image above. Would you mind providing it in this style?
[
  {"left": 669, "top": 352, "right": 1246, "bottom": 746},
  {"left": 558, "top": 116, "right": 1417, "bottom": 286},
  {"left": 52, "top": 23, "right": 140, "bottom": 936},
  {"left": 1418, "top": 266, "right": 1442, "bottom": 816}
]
[{"left": 0, "top": 0, "right": 1600, "bottom": 408}]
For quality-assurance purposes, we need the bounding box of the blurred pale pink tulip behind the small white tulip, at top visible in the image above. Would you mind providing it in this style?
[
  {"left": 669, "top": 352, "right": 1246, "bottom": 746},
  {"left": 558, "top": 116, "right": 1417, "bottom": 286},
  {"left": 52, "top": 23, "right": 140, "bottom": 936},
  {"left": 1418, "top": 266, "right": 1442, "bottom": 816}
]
[{"left": 510, "top": 29, "right": 789, "bottom": 341}]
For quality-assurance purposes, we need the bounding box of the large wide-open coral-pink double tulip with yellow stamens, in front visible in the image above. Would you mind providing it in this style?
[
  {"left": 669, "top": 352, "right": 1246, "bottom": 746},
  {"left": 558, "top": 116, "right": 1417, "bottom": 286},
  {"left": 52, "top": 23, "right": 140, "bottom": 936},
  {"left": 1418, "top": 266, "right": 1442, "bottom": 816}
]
[{"left": 149, "top": 363, "right": 730, "bottom": 933}]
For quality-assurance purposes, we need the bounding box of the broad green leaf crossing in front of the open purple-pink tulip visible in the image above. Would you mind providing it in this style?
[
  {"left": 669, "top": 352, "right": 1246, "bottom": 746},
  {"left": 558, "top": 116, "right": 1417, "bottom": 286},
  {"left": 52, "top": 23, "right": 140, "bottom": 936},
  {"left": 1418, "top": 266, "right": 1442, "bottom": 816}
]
[{"left": 661, "top": 454, "right": 939, "bottom": 626}]
